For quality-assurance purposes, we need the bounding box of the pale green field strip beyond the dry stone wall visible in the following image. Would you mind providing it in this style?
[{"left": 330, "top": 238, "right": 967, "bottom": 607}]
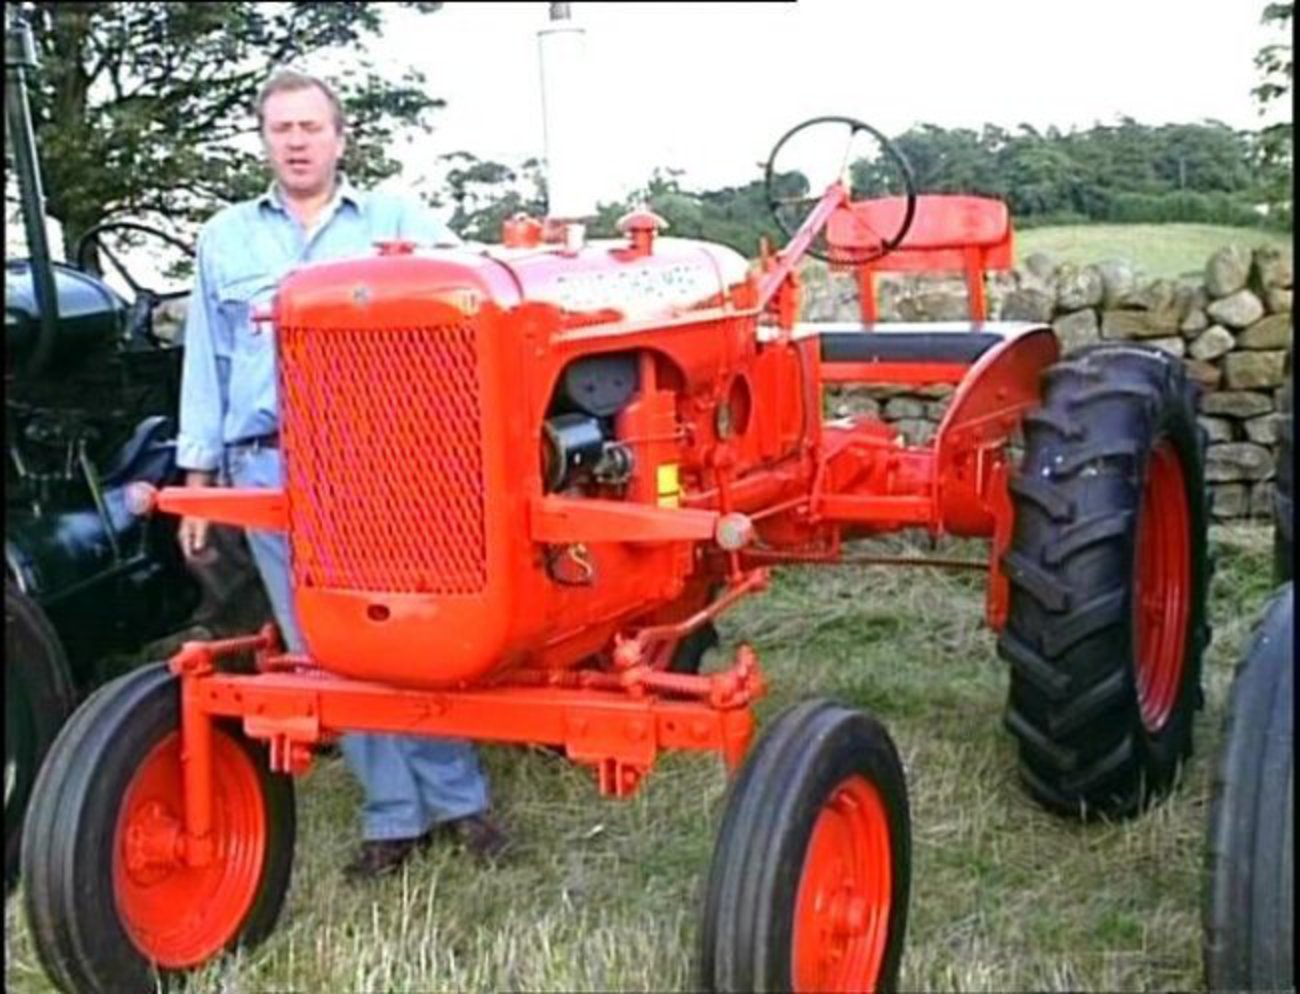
[{"left": 1015, "top": 223, "right": 1291, "bottom": 279}]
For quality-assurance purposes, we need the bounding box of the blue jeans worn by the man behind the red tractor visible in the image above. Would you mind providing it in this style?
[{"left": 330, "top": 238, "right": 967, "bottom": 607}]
[{"left": 226, "top": 447, "right": 488, "bottom": 839}]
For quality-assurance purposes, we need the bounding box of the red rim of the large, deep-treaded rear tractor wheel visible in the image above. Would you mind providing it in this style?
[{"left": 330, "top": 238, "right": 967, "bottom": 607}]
[{"left": 1134, "top": 440, "right": 1192, "bottom": 733}]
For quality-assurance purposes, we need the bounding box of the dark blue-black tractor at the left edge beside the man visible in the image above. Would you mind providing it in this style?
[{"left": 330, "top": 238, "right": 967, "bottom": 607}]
[{"left": 4, "top": 17, "right": 270, "bottom": 891}]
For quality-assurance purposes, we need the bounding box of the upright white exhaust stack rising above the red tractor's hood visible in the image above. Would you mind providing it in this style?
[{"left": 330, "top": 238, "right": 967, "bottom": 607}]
[{"left": 537, "top": 3, "right": 595, "bottom": 232}]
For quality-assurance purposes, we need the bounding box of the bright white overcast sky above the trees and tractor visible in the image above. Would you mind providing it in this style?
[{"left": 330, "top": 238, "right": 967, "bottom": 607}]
[{"left": 376, "top": 0, "right": 1286, "bottom": 200}]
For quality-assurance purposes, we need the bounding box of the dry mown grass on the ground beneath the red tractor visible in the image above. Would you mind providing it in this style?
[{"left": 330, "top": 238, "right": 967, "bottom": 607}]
[{"left": 5, "top": 526, "right": 1271, "bottom": 994}]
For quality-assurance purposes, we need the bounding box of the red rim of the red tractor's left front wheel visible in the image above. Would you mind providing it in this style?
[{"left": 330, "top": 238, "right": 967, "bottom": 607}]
[{"left": 113, "top": 732, "right": 267, "bottom": 969}]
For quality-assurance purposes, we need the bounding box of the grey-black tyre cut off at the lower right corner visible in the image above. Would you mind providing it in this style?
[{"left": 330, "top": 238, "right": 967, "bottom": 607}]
[{"left": 1204, "top": 583, "right": 1295, "bottom": 990}]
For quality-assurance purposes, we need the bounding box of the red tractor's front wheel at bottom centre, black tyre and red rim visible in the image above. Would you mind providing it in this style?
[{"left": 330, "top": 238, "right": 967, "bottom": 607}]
[{"left": 696, "top": 700, "right": 911, "bottom": 991}]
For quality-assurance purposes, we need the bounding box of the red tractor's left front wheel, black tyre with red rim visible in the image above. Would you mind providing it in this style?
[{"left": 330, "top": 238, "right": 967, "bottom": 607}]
[{"left": 22, "top": 664, "right": 295, "bottom": 994}]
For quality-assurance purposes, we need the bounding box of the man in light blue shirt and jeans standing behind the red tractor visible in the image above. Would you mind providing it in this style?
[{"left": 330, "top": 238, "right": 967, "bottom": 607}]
[{"left": 177, "top": 71, "right": 504, "bottom": 880}]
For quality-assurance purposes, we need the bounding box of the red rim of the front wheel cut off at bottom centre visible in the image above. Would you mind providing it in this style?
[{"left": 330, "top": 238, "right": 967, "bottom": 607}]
[{"left": 793, "top": 776, "right": 893, "bottom": 991}]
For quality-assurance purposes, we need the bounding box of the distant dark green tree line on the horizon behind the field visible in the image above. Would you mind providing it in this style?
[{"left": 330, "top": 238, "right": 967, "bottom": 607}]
[{"left": 449, "top": 117, "right": 1291, "bottom": 255}]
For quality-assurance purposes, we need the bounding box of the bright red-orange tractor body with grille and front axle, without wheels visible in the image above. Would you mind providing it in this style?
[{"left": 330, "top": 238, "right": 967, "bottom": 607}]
[{"left": 142, "top": 185, "right": 1057, "bottom": 865}]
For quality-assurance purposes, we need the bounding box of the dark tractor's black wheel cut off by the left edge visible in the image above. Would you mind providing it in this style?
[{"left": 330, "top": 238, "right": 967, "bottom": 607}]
[{"left": 4, "top": 583, "right": 77, "bottom": 893}]
